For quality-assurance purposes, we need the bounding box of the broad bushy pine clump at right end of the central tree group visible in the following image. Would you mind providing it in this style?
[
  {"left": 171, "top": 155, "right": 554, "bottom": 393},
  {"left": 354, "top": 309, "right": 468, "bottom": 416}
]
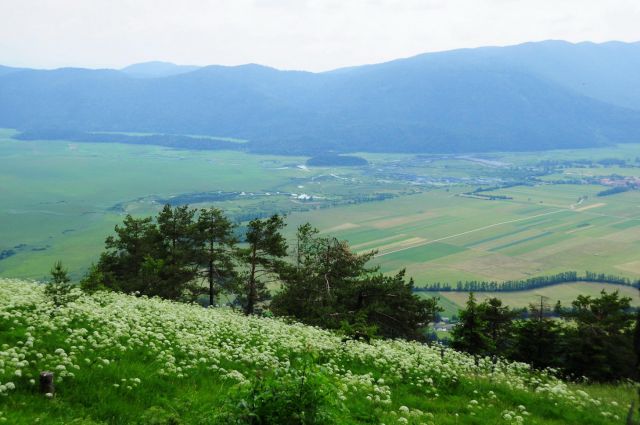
[{"left": 271, "top": 224, "right": 440, "bottom": 339}]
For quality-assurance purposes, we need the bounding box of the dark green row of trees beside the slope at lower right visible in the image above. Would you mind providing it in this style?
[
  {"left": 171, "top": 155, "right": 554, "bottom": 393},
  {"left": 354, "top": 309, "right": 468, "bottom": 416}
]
[{"left": 452, "top": 291, "right": 640, "bottom": 381}]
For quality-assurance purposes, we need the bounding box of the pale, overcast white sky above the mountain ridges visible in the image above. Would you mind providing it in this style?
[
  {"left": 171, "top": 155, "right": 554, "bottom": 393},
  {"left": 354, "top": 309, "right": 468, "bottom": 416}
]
[{"left": 0, "top": 0, "right": 640, "bottom": 71}]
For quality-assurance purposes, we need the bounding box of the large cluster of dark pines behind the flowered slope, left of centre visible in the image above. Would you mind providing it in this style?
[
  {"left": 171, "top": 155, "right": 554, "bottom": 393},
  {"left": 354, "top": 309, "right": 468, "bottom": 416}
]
[{"left": 81, "top": 205, "right": 441, "bottom": 339}]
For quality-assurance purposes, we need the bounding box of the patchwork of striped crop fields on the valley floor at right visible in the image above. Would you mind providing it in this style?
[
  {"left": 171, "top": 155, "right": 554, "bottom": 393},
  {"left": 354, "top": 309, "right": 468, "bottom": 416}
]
[{"left": 291, "top": 185, "right": 640, "bottom": 285}]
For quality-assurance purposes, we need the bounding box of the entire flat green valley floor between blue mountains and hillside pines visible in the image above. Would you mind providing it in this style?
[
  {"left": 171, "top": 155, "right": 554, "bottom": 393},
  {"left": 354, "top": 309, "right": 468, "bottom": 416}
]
[{"left": 0, "top": 130, "right": 640, "bottom": 285}]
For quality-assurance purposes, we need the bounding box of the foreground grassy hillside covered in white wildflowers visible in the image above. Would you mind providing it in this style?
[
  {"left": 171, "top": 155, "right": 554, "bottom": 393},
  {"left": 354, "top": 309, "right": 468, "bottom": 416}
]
[{"left": 0, "top": 280, "right": 633, "bottom": 425}]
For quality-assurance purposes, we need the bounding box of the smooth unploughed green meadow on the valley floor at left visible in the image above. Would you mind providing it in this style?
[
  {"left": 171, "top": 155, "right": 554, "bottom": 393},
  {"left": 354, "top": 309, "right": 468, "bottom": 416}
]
[{"left": 0, "top": 130, "right": 410, "bottom": 279}]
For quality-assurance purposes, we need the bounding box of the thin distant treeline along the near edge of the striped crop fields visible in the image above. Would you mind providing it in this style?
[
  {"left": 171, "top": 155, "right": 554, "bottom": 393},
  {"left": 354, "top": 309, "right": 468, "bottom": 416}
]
[{"left": 414, "top": 271, "right": 640, "bottom": 292}]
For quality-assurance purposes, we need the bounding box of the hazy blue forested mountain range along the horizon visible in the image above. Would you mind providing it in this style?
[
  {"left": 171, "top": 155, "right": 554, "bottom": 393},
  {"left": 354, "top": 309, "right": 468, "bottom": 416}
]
[{"left": 0, "top": 41, "right": 640, "bottom": 153}]
